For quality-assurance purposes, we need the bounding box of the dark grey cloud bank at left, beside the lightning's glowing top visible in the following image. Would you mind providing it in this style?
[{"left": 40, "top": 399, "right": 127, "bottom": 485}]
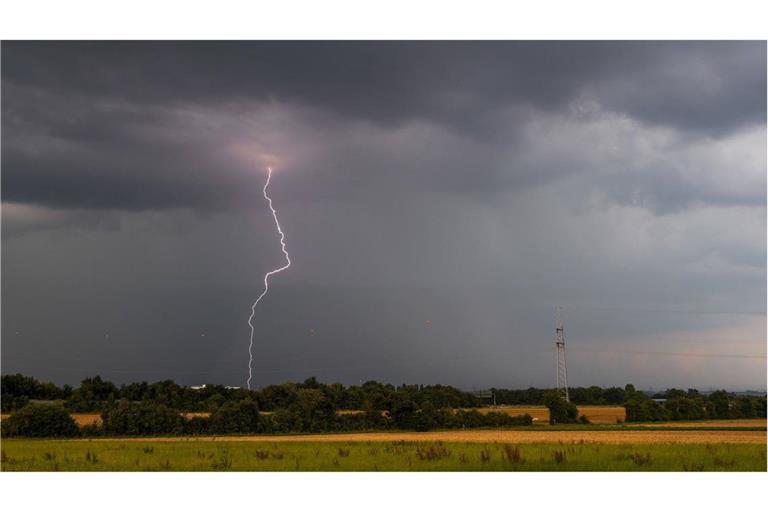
[{"left": 3, "top": 86, "right": 252, "bottom": 210}]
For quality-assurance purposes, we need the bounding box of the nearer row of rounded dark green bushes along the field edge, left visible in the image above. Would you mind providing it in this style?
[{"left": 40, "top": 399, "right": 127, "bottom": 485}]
[{"left": 0, "top": 396, "right": 532, "bottom": 438}]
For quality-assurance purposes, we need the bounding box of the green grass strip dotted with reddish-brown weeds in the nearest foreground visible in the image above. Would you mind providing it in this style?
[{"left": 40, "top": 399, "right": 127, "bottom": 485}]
[{"left": 2, "top": 440, "right": 766, "bottom": 471}]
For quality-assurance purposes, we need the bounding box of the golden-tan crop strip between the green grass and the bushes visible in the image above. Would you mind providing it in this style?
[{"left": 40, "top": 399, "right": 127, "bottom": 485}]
[{"left": 93, "top": 430, "right": 767, "bottom": 444}]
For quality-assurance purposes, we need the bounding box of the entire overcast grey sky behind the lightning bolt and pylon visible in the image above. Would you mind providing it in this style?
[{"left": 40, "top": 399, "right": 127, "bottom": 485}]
[{"left": 2, "top": 42, "right": 766, "bottom": 389}]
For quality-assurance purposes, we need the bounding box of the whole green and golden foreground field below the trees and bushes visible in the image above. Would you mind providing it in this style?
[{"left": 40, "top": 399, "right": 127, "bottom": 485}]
[{"left": 0, "top": 407, "right": 767, "bottom": 471}]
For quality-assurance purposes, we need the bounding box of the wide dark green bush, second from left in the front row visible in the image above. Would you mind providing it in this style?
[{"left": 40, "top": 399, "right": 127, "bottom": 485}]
[{"left": 101, "top": 402, "right": 183, "bottom": 436}]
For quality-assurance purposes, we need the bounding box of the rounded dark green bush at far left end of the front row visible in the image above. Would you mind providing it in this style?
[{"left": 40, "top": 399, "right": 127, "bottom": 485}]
[{"left": 3, "top": 404, "right": 80, "bottom": 437}]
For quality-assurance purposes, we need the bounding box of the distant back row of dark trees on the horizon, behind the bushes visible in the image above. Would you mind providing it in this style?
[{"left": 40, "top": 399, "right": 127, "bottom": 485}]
[{"left": 7, "top": 374, "right": 759, "bottom": 412}]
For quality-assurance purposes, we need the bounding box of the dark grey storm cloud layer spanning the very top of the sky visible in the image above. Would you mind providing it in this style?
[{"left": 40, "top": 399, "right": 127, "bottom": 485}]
[{"left": 3, "top": 42, "right": 766, "bottom": 130}]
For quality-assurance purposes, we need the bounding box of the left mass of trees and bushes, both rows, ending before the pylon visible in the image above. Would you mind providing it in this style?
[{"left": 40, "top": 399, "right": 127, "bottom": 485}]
[{"left": 2, "top": 374, "right": 532, "bottom": 437}]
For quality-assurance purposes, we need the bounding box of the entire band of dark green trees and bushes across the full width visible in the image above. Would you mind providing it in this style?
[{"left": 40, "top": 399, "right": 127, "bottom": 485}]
[{"left": 1, "top": 374, "right": 766, "bottom": 437}]
